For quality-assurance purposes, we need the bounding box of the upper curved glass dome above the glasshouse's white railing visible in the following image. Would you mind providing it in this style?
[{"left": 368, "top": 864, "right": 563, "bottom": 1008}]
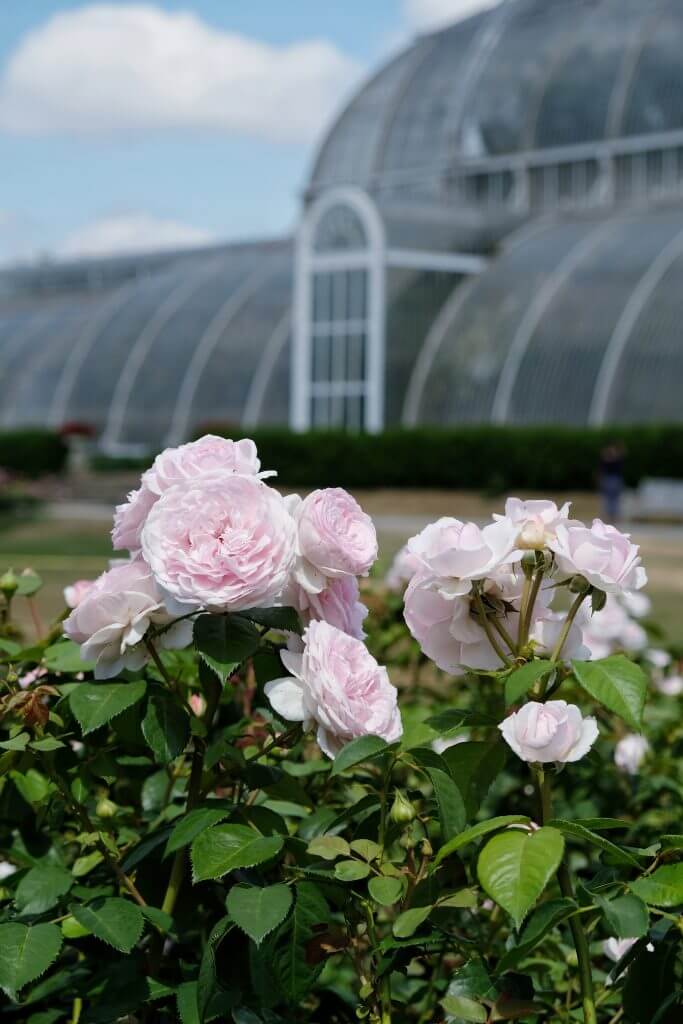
[{"left": 309, "top": 0, "right": 683, "bottom": 195}]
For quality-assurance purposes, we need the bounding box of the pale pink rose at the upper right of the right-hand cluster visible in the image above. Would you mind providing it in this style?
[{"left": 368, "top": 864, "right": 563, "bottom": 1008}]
[{"left": 550, "top": 519, "right": 647, "bottom": 594}]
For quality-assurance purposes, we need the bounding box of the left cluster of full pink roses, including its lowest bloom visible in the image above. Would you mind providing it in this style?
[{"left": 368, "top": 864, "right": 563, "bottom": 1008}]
[{"left": 65, "top": 435, "right": 400, "bottom": 753}]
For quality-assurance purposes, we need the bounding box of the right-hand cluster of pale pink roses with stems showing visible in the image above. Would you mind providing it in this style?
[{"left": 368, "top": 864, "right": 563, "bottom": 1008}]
[{"left": 401, "top": 498, "right": 646, "bottom": 675}]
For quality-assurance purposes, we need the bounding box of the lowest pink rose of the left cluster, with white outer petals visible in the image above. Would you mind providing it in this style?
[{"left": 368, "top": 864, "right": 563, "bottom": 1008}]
[{"left": 265, "top": 622, "right": 402, "bottom": 758}]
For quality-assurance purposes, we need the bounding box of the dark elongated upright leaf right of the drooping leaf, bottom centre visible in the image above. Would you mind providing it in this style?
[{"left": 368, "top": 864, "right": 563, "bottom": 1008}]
[{"left": 273, "top": 882, "right": 330, "bottom": 1006}]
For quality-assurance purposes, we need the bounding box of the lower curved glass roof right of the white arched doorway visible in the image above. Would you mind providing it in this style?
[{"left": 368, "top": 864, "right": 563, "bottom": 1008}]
[{"left": 404, "top": 209, "right": 683, "bottom": 425}]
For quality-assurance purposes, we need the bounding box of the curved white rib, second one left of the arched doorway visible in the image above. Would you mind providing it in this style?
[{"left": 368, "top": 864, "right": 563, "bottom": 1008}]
[{"left": 165, "top": 261, "right": 273, "bottom": 445}]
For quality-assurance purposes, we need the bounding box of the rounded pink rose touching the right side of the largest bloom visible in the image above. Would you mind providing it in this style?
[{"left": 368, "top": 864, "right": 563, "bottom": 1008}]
[{"left": 288, "top": 487, "right": 377, "bottom": 593}]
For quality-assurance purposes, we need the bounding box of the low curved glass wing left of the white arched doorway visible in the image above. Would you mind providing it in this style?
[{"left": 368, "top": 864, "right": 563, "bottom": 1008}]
[{"left": 0, "top": 241, "right": 293, "bottom": 447}]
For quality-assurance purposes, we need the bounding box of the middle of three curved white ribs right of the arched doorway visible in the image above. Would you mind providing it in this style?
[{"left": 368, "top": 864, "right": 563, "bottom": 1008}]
[{"left": 492, "top": 220, "right": 620, "bottom": 423}]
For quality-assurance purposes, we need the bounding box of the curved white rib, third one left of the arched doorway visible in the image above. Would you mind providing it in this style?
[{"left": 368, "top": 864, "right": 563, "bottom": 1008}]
[{"left": 101, "top": 259, "right": 221, "bottom": 451}]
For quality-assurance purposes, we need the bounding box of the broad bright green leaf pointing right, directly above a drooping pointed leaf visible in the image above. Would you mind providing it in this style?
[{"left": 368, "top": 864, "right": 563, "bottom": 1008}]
[{"left": 191, "top": 825, "right": 285, "bottom": 882}]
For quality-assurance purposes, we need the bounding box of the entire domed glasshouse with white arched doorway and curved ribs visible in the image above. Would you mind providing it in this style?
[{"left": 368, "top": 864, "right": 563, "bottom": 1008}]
[{"left": 0, "top": 0, "right": 683, "bottom": 452}]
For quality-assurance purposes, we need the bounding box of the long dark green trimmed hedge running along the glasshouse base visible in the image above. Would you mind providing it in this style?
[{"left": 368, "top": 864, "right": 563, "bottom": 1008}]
[{"left": 96, "top": 424, "right": 683, "bottom": 494}]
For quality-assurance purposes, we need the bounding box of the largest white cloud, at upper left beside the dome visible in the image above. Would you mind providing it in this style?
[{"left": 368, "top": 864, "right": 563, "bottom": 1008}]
[{"left": 0, "top": 3, "right": 360, "bottom": 142}]
